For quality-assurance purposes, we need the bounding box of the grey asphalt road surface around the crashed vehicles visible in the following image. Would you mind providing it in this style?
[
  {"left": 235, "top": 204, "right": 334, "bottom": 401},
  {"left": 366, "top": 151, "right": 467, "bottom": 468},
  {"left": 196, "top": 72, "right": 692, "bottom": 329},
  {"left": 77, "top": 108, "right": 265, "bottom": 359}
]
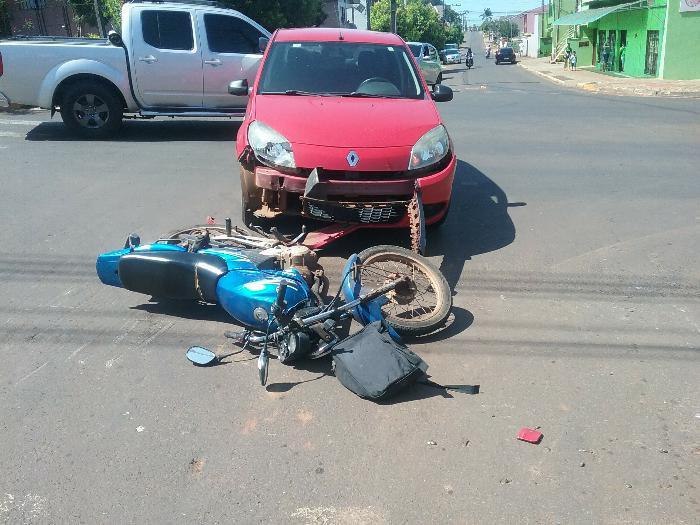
[{"left": 0, "top": 35, "right": 700, "bottom": 524}]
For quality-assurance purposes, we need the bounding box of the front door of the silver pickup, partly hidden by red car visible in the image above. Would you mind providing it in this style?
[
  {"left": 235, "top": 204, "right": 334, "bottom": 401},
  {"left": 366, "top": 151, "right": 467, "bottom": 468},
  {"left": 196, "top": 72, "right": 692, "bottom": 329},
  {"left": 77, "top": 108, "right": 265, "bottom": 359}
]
[{"left": 197, "top": 11, "right": 270, "bottom": 108}]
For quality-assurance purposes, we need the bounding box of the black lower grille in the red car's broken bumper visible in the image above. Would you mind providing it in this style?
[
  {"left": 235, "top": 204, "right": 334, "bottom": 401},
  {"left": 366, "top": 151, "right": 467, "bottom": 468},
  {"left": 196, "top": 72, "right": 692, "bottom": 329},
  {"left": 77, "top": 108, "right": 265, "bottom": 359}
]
[{"left": 302, "top": 198, "right": 408, "bottom": 224}]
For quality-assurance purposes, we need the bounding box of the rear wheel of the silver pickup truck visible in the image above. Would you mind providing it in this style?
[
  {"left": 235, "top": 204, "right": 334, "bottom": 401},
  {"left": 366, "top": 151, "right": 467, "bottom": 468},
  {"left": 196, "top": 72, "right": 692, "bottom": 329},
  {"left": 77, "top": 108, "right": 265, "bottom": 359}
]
[{"left": 61, "top": 82, "right": 123, "bottom": 139}]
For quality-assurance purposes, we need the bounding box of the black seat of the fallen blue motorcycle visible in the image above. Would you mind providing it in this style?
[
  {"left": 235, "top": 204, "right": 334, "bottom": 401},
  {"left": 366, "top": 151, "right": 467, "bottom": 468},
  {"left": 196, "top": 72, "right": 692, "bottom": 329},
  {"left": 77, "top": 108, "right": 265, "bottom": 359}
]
[{"left": 118, "top": 251, "right": 228, "bottom": 303}]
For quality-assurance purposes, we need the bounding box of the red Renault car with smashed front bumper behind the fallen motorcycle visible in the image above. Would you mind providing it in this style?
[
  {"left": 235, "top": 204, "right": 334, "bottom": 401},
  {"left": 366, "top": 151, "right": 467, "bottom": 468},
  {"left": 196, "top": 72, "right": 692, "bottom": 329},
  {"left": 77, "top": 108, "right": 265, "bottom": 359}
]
[{"left": 229, "top": 28, "right": 456, "bottom": 233}]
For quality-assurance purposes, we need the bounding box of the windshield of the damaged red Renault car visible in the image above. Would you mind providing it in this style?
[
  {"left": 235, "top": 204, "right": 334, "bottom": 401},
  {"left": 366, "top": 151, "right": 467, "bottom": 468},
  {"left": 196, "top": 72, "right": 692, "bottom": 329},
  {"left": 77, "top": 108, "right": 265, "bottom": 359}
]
[{"left": 258, "top": 42, "right": 424, "bottom": 99}]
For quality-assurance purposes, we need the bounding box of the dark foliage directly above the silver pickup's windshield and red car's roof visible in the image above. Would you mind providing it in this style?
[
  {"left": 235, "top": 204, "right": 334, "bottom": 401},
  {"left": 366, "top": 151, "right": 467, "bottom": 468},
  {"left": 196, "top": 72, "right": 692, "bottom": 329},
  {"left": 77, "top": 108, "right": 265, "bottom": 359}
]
[{"left": 220, "top": 0, "right": 326, "bottom": 31}]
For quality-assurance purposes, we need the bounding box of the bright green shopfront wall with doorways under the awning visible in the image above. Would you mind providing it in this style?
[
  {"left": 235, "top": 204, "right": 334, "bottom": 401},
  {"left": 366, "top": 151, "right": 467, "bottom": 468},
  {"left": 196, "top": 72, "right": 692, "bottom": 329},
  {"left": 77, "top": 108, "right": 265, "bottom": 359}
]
[{"left": 590, "top": 4, "right": 664, "bottom": 77}]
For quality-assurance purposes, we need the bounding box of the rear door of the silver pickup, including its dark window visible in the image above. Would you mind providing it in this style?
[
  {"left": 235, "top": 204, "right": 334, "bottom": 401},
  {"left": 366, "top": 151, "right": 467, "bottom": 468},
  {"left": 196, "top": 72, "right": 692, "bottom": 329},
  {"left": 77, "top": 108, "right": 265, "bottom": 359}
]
[{"left": 129, "top": 4, "right": 202, "bottom": 108}]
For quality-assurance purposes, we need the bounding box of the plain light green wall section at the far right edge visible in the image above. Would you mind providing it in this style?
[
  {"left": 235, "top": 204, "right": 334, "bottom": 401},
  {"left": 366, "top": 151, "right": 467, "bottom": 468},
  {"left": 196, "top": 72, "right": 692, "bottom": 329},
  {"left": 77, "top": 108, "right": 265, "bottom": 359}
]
[{"left": 660, "top": 0, "right": 700, "bottom": 80}]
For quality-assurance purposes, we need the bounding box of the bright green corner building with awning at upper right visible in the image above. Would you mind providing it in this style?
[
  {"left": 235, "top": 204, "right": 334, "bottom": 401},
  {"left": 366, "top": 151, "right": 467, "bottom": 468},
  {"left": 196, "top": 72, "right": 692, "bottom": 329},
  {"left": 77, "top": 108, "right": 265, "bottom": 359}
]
[{"left": 552, "top": 0, "right": 700, "bottom": 79}]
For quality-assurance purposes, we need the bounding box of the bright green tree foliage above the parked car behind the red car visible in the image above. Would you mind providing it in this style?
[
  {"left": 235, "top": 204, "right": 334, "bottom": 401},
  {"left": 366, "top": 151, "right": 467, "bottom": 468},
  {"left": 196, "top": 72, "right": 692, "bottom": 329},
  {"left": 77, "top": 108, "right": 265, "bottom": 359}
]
[{"left": 371, "top": 0, "right": 464, "bottom": 49}]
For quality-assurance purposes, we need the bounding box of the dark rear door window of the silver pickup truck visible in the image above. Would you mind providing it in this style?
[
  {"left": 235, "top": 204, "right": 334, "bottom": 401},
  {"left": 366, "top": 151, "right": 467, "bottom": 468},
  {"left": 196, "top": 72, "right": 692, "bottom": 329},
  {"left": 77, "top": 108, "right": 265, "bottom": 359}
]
[{"left": 141, "top": 11, "right": 194, "bottom": 51}]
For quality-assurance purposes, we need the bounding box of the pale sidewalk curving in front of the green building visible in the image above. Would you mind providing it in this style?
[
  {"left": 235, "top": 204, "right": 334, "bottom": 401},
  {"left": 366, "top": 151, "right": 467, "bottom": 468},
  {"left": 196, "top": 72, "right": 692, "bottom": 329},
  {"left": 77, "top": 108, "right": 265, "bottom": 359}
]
[{"left": 518, "top": 57, "right": 700, "bottom": 98}]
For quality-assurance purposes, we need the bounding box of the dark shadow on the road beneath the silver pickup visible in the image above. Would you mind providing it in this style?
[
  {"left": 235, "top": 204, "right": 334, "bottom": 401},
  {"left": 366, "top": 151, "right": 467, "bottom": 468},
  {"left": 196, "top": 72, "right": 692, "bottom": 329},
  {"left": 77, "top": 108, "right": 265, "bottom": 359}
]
[{"left": 26, "top": 120, "right": 241, "bottom": 142}]
